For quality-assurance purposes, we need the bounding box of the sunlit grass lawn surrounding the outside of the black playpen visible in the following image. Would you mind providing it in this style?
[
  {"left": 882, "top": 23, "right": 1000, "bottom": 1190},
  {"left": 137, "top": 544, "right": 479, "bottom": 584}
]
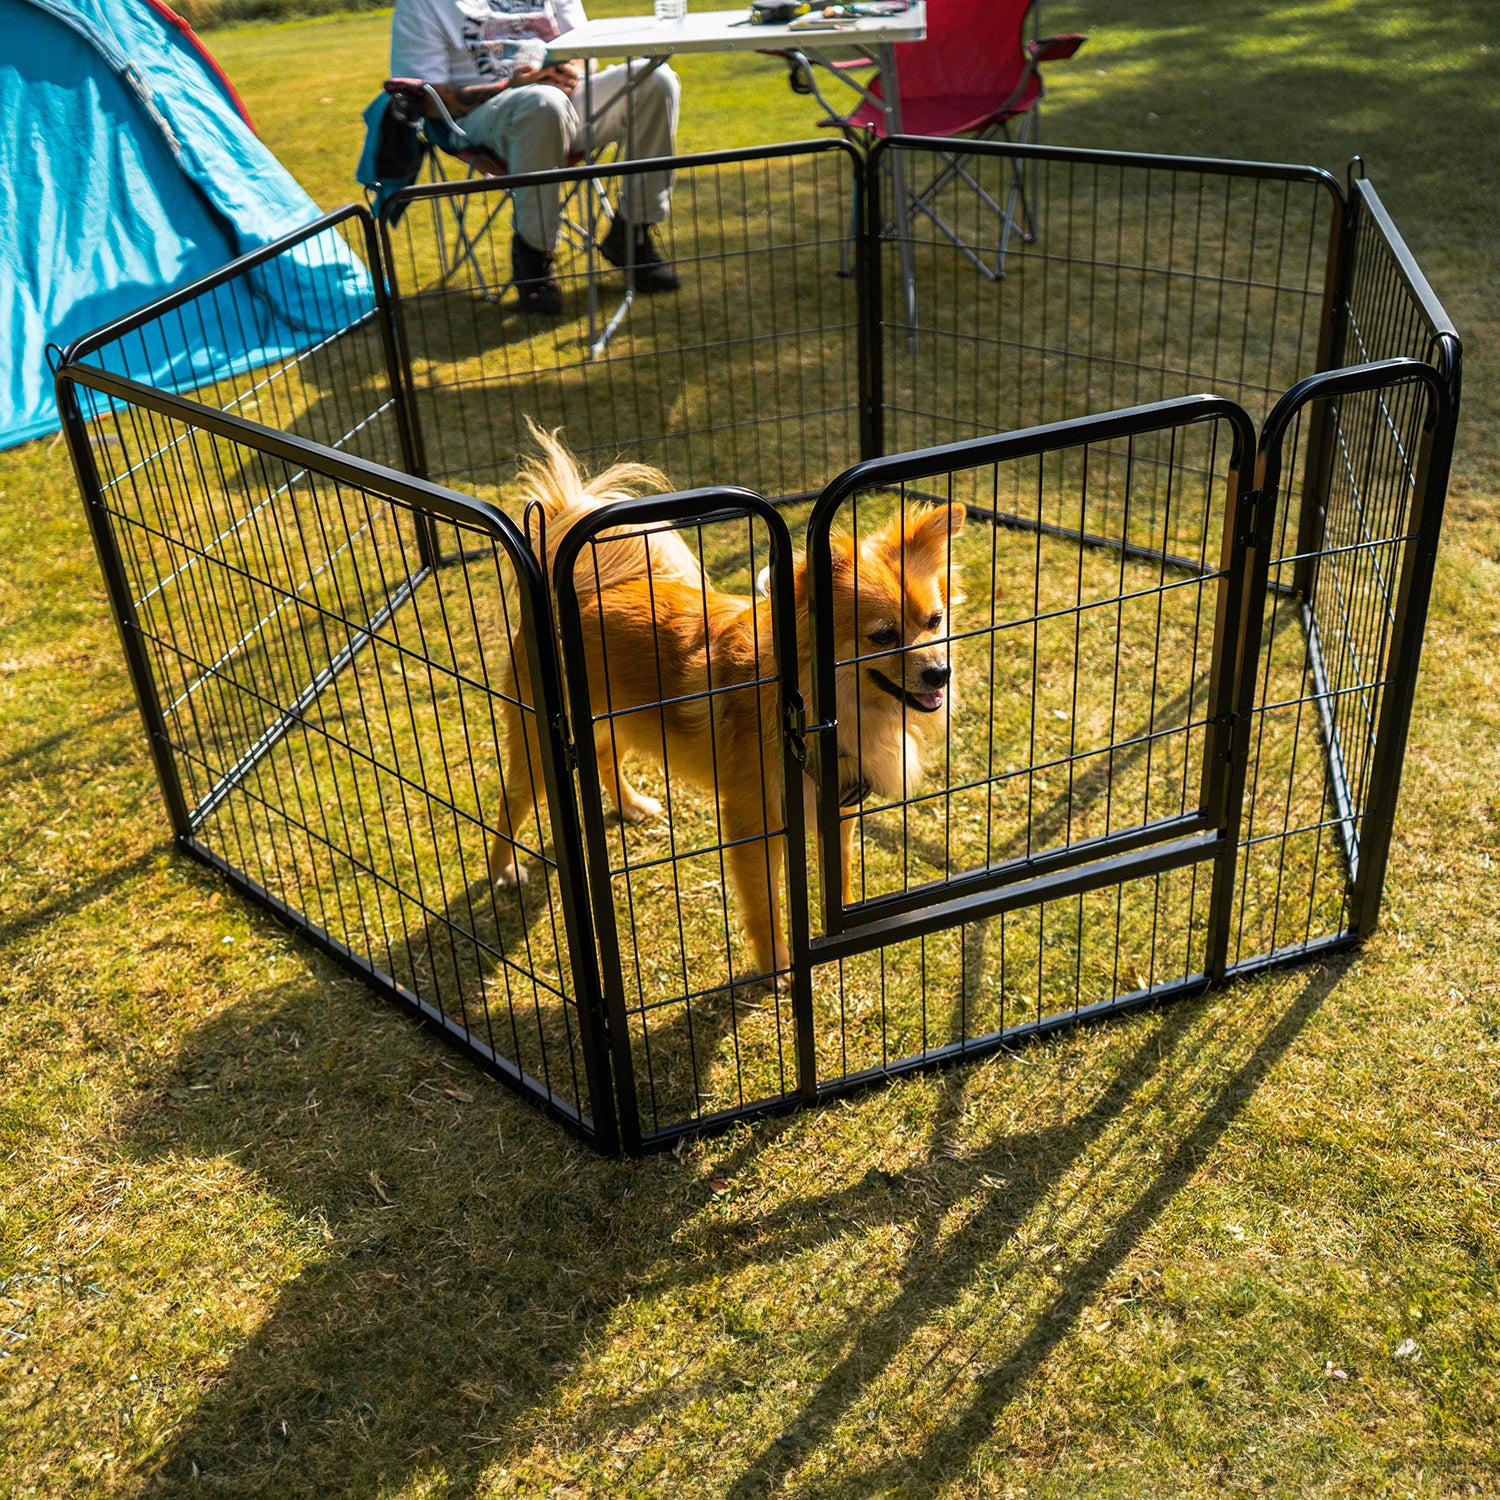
[{"left": 0, "top": 0, "right": 1500, "bottom": 1500}]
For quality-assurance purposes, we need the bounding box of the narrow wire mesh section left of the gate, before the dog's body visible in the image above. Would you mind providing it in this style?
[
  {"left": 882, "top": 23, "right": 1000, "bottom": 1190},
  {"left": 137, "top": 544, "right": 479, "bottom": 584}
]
[{"left": 555, "top": 492, "right": 810, "bottom": 1140}]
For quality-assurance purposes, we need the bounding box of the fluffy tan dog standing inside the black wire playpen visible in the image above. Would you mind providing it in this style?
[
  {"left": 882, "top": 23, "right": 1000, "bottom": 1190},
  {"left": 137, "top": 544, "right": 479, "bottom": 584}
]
[{"left": 489, "top": 428, "right": 965, "bottom": 983}]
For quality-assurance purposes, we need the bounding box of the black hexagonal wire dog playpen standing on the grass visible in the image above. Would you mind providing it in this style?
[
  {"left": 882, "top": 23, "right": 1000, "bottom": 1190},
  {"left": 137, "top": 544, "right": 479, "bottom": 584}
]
[{"left": 59, "top": 138, "right": 1460, "bottom": 1151}]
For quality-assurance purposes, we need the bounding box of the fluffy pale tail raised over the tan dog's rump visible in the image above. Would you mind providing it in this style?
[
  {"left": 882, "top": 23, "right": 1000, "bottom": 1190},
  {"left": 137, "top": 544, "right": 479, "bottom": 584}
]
[{"left": 519, "top": 417, "right": 704, "bottom": 596}]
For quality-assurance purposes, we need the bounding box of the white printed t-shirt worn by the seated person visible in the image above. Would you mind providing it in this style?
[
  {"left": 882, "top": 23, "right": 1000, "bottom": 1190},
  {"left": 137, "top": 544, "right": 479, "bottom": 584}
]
[{"left": 390, "top": 0, "right": 588, "bottom": 89}]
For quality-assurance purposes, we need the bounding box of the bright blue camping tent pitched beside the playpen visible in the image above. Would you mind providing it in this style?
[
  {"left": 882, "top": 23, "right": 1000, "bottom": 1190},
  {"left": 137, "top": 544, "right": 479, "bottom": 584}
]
[{"left": 0, "top": 0, "right": 371, "bottom": 447}]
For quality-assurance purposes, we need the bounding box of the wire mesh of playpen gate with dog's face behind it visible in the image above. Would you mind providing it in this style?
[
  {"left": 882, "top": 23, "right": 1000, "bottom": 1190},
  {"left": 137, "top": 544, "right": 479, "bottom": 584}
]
[{"left": 810, "top": 398, "right": 1253, "bottom": 930}]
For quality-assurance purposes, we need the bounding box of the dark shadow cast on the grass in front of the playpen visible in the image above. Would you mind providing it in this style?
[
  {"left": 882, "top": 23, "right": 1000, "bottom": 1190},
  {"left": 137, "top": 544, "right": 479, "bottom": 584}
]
[{"left": 126, "top": 894, "right": 1341, "bottom": 1497}]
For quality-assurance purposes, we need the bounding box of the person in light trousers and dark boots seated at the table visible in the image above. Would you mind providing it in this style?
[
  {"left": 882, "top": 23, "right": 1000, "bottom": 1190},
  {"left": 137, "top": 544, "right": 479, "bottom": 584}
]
[{"left": 390, "top": 0, "right": 681, "bottom": 314}]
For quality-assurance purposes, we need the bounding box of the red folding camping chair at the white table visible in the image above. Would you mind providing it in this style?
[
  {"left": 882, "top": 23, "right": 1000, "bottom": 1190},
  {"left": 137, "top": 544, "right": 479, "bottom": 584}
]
[{"left": 788, "top": 0, "right": 1086, "bottom": 298}]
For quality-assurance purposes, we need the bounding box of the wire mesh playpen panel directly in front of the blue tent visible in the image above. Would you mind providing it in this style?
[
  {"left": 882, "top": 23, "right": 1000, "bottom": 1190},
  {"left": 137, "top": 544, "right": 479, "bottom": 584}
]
[{"left": 65, "top": 207, "right": 410, "bottom": 468}]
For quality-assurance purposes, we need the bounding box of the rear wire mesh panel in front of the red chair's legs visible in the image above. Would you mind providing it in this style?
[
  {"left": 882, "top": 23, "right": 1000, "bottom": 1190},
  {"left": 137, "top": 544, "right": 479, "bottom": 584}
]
[{"left": 873, "top": 140, "right": 1343, "bottom": 453}]
